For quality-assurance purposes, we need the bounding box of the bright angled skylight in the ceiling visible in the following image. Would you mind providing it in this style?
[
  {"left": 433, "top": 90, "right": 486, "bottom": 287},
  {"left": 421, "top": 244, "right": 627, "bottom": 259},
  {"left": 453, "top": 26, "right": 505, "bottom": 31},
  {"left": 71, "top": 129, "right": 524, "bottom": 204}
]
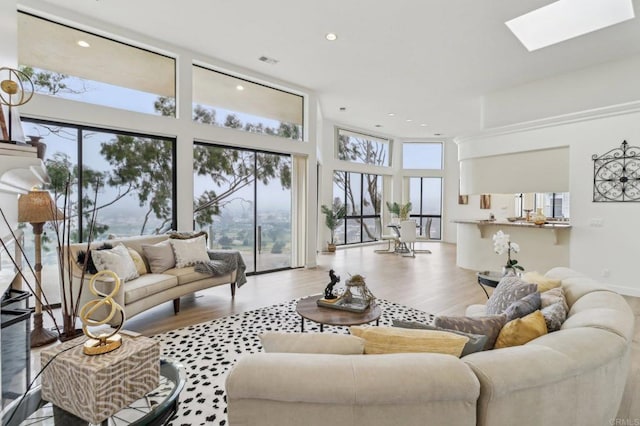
[{"left": 505, "top": 0, "right": 635, "bottom": 51}]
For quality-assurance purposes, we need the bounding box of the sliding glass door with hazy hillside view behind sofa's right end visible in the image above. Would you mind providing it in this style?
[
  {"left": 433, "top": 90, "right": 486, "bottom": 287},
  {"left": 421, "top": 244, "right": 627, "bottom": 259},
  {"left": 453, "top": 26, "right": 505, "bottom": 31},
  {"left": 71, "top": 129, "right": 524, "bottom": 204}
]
[{"left": 194, "top": 144, "right": 291, "bottom": 273}]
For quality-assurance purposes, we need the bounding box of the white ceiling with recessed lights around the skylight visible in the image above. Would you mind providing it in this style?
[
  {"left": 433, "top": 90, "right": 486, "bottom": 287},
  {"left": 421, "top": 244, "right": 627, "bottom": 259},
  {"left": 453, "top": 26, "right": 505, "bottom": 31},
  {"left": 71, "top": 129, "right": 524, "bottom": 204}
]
[{"left": 30, "top": 0, "right": 640, "bottom": 138}]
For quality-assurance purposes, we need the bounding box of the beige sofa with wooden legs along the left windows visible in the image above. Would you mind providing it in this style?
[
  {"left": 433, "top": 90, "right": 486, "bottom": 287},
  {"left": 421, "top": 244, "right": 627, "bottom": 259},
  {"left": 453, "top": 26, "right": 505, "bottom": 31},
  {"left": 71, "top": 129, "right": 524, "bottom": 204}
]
[{"left": 66, "top": 235, "right": 243, "bottom": 323}]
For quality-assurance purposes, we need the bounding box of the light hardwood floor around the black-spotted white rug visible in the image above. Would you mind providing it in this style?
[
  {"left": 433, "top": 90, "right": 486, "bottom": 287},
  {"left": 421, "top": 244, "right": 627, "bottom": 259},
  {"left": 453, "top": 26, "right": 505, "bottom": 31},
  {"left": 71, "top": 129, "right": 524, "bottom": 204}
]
[{"left": 41, "top": 242, "right": 640, "bottom": 424}]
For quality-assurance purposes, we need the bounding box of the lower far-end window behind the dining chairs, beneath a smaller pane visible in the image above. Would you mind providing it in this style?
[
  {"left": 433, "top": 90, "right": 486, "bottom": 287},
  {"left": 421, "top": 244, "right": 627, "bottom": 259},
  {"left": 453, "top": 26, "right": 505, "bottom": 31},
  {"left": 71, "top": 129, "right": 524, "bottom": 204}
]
[{"left": 409, "top": 177, "right": 442, "bottom": 240}]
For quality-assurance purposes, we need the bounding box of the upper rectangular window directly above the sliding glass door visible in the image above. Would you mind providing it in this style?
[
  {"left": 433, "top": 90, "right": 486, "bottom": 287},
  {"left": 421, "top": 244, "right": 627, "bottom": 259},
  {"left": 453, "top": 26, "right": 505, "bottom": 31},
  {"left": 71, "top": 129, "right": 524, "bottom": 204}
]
[{"left": 193, "top": 65, "right": 304, "bottom": 140}]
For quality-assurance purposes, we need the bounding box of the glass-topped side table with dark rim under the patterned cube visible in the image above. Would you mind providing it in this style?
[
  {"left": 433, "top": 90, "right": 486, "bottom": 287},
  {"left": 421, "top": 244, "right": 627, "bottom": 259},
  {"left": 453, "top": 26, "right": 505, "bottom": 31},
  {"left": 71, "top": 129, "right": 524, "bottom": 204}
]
[{"left": 2, "top": 359, "right": 186, "bottom": 426}]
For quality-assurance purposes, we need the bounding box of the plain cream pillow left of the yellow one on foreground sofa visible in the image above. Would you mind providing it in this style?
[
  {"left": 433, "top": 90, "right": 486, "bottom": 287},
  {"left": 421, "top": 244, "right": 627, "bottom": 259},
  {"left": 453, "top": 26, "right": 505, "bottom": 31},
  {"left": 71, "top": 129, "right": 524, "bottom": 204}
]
[{"left": 259, "top": 331, "right": 364, "bottom": 355}]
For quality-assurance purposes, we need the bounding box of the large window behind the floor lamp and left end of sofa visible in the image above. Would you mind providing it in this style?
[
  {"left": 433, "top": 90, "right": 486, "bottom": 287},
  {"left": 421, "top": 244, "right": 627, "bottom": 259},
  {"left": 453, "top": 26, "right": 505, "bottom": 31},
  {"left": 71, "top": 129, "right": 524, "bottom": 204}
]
[{"left": 23, "top": 119, "right": 176, "bottom": 303}]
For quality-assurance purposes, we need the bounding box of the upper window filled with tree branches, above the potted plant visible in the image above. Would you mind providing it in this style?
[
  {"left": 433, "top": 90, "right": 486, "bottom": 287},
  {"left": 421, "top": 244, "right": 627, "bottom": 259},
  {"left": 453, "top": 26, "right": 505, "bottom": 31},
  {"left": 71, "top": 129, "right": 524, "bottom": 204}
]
[{"left": 336, "top": 129, "right": 391, "bottom": 166}]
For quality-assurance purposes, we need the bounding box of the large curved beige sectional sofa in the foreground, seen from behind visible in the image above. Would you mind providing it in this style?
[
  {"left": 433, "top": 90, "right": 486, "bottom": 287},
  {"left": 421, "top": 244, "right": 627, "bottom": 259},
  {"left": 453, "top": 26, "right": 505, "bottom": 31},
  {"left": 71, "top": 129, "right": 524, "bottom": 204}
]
[{"left": 226, "top": 268, "right": 634, "bottom": 426}]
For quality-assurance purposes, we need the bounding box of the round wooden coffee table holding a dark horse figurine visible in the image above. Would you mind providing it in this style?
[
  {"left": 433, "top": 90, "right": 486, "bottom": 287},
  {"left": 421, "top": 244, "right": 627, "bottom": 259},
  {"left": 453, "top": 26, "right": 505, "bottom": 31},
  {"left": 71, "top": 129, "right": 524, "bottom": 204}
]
[{"left": 296, "top": 294, "right": 382, "bottom": 331}]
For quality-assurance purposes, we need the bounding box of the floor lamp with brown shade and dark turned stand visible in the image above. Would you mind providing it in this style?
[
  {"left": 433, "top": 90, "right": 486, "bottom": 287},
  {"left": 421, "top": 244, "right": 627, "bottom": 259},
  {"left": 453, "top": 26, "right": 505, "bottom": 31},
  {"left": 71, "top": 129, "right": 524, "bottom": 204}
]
[{"left": 18, "top": 190, "right": 63, "bottom": 348}]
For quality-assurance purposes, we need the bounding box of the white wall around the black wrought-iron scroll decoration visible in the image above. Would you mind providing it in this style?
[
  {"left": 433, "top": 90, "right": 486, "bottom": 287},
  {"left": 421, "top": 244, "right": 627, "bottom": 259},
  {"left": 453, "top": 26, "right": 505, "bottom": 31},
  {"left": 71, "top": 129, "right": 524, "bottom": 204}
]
[{"left": 459, "top": 110, "right": 640, "bottom": 296}]
